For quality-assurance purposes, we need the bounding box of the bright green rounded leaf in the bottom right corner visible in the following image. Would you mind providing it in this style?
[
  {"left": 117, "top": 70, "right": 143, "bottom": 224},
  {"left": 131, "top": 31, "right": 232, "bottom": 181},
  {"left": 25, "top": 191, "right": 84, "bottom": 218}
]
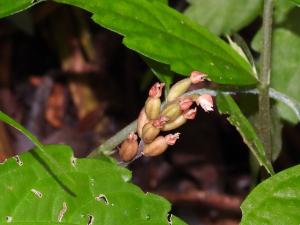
[{"left": 241, "top": 165, "right": 300, "bottom": 225}]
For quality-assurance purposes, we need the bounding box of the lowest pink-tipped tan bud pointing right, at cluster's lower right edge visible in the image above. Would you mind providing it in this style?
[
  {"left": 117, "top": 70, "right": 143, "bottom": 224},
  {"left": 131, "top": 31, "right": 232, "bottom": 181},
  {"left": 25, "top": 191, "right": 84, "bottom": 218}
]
[{"left": 143, "top": 133, "right": 180, "bottom": 156}]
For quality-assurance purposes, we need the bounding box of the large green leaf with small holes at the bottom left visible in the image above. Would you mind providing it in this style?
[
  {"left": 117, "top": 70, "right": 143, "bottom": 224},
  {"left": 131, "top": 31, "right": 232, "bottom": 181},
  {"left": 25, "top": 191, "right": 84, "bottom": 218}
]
[{"left": 0, "top": 145, "right": 185, "bottom": 225}]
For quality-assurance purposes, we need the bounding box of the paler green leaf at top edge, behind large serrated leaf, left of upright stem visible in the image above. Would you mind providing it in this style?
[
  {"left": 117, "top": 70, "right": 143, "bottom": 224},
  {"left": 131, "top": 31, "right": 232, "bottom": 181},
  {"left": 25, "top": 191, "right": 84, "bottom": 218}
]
[{"left": 184, "top": 0, "right": 262, "bottom": 35}]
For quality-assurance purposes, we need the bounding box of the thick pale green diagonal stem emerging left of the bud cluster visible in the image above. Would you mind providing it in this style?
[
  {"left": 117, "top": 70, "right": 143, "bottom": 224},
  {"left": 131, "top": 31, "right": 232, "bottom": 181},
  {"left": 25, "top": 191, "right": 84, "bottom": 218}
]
[{"left": 88, "top": 120, "right": 137, "bottom": 158}]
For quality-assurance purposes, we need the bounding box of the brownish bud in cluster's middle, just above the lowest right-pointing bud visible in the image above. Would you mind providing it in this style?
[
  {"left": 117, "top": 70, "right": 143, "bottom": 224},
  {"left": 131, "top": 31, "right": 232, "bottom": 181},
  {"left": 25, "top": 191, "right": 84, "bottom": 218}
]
[{"left": 142, "top": 117, "right": 167, "bottom": 144}]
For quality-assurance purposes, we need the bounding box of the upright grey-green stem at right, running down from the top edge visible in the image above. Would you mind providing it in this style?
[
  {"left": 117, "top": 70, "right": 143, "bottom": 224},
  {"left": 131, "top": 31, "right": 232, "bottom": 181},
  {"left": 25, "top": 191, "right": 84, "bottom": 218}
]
[{"left": 258, "top": 0, "right": 273, "bottom": 161}]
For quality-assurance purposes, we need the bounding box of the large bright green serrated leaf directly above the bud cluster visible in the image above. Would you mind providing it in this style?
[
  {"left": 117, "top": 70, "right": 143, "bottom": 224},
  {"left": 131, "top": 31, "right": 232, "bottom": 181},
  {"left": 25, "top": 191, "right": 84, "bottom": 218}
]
[{"left": 54, "top": 0, "right": 257, "bottom": 85}]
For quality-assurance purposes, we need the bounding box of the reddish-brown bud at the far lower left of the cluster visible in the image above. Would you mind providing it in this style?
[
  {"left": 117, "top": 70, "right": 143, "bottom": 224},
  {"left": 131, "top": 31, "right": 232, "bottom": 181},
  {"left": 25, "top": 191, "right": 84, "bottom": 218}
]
[{"left": 119, "top": 133, "right": 138, "bottom": 162}]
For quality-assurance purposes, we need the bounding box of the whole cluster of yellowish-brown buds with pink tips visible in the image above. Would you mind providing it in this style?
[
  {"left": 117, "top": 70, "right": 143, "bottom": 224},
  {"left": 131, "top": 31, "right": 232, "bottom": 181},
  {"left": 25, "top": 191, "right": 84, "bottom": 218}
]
[{"left": 119, "top": 71, "right": 213, "bottom": 162}]
